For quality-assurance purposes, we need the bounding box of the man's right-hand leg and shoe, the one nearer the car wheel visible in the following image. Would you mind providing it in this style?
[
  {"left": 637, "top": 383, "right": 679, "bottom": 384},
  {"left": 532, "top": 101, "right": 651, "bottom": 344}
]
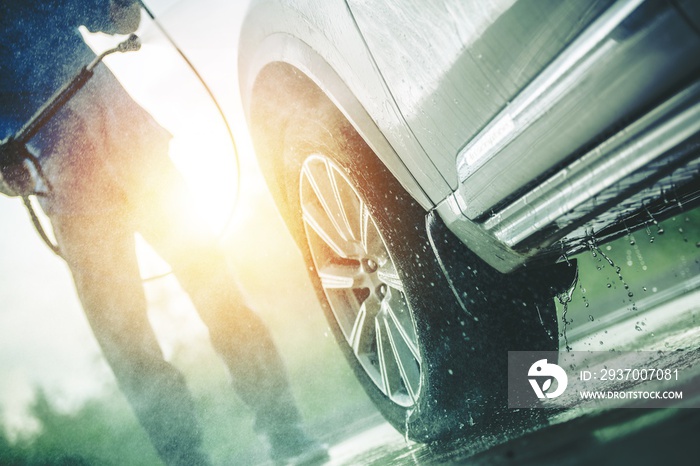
[{"left": 139, "top": 170, "right": 325, "bottom": 456}]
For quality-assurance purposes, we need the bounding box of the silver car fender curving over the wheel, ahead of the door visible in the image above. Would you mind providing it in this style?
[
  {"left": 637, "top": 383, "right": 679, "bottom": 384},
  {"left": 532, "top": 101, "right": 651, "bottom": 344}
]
[{"left": 239, "top": 0, "right": 451, "bottom": 209}]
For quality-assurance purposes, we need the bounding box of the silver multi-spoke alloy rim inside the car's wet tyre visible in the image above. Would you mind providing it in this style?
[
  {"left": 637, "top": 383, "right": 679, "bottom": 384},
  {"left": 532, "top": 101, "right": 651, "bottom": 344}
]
[{"left": 300, "top": 155, "right": 421, "bottom": 408}]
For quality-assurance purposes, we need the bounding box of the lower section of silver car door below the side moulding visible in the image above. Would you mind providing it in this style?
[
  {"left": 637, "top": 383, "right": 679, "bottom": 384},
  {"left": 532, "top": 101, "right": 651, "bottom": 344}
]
[{"left": 460, "top": 2, "right": 700, "bottom": 219}]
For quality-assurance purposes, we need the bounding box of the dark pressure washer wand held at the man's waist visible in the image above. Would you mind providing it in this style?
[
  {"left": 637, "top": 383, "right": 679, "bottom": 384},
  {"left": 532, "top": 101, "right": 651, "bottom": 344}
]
[{"left": 12, "top": 34, "right": 141, "bottom": 144}]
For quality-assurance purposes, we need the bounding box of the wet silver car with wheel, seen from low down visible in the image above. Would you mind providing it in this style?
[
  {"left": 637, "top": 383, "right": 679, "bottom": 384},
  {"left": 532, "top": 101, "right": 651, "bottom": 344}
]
[{"left": 231, "top": 0, "right": 700, "bottom": 441}]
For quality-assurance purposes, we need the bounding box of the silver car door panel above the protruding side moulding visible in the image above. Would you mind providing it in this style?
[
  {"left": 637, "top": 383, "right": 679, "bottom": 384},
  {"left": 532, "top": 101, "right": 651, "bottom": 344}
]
[{"left": 348, "top": 0, "right": 611, "bottom": 189}]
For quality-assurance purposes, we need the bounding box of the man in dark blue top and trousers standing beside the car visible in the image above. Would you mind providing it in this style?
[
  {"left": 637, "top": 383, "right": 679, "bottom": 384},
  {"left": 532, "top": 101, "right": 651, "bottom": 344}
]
[{"left": 0, "top": 0, "right": 327, "bottom": 465}]
